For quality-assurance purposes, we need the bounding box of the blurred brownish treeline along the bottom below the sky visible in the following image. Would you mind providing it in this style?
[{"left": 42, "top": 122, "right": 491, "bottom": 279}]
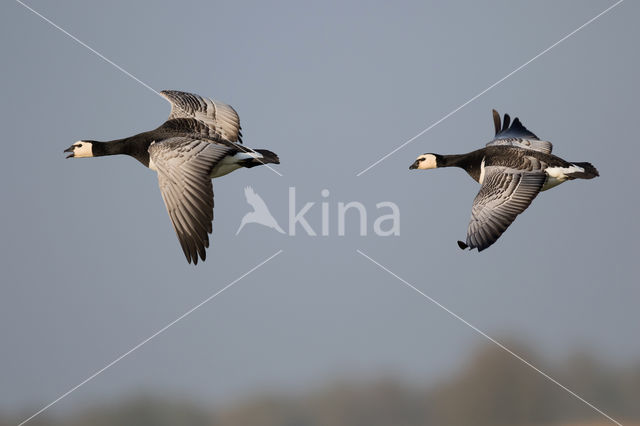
[{"left": 0, "top": 342, "right": 640, "bottom": 426}]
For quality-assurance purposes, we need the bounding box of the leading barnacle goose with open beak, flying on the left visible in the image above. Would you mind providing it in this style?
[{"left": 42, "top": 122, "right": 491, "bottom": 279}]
[{"left": 64, "top": 90, "right": 280, "bottom": 264}]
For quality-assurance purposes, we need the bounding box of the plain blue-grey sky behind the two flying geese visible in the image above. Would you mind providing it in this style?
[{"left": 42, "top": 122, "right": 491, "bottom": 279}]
[{"left": 0, "top": 0, "right": 640, "bottom": 420}]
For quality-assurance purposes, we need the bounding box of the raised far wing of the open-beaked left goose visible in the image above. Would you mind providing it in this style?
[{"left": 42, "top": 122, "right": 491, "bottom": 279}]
[{"left": 160, "top": 90, "right": 242, "bottom": 143}]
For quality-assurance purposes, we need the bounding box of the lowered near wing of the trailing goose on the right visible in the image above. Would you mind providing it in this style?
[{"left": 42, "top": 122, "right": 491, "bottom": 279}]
[{"left": 458, "top": 166, "right": 546, "bottom": 251}]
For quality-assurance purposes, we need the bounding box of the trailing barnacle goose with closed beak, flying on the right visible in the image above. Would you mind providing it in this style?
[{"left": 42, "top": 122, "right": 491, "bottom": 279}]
[{"left": 409, "top": 110, "right": 599, "bottom": 251}]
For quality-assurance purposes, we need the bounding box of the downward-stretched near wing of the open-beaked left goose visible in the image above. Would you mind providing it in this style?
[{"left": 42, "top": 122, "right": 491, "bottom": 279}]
[{"left": 149, "top": 137, "right": 231, "bottom": 264}]
